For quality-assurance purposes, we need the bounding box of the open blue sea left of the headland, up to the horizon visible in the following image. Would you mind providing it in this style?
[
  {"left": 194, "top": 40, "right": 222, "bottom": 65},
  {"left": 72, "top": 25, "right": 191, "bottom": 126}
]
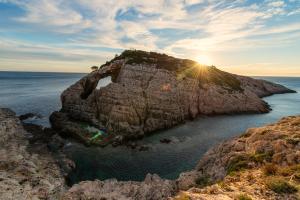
[{"left": 0, "top": 72, "right": 84, "bottom": 126}]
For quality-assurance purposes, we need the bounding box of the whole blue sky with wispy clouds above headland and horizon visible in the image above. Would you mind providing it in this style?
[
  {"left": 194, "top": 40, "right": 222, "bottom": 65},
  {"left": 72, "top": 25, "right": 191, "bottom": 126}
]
[{"left": 0, "top": 0, "right": 300, "bottom": 76}]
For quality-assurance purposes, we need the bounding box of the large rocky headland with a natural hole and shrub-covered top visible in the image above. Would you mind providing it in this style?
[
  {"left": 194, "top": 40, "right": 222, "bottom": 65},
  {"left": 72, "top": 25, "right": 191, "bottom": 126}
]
[{"left": 51, "top": 51, "right": 292, "bottom": 143}]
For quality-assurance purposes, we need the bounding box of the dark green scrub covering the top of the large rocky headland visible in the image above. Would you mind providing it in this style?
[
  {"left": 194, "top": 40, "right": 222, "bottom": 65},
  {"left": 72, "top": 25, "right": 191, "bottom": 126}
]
[{"left": 101, "top": 50, "right": 243, "bottom": 92}]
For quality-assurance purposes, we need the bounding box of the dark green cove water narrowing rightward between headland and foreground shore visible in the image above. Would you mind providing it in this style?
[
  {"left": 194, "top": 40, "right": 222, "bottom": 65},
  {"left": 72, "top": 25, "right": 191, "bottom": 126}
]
[{"left": 64, "top": 77, "right": 300, "bottom": 185}]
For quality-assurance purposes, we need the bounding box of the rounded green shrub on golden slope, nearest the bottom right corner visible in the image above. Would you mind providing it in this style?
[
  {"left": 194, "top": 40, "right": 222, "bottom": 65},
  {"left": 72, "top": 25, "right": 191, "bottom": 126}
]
[{"left": 266, "top": 177, "right": 298, "bottom": 194}]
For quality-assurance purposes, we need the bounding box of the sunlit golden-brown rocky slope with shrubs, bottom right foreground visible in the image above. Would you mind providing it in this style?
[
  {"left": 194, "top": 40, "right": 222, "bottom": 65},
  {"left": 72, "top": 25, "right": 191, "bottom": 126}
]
[{"left": 177, "top": 116, "right": 300, "bottom": 199}]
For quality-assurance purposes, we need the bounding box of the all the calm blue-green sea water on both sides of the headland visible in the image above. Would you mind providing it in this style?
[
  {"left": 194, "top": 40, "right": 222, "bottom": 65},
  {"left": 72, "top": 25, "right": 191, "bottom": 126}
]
[{"left": 0, "top": 72, "right": 300, "bottom": 183}]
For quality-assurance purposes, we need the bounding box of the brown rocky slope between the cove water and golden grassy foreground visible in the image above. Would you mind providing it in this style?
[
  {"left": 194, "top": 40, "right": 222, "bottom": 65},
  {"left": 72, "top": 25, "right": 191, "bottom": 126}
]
[{"left": 177, "top": 116, "right": 300, "bottom": 189}]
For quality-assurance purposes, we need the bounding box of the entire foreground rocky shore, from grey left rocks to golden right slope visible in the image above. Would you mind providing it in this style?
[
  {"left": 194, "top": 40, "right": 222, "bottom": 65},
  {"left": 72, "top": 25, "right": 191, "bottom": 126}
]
[{"left": 0, "top": 109, "right": 300, "bottom": 200}]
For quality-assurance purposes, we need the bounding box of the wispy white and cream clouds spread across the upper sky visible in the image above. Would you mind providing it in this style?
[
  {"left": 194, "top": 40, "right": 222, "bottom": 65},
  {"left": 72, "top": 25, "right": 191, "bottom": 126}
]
[{"left": 0, "top": 0, "right": 300, "bottom": 72}]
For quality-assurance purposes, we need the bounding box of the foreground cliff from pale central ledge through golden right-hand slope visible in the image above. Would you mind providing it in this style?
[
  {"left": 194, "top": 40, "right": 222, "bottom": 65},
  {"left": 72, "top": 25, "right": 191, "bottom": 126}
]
[{"left": 63, "top": 116, "right": 300, "bottom": 200}]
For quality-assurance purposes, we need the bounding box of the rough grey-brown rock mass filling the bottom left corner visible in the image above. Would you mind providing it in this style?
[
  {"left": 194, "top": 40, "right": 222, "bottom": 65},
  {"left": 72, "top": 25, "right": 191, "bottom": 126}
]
[{"left": 0, "top": 109, "right": 65, "bottom": 200}]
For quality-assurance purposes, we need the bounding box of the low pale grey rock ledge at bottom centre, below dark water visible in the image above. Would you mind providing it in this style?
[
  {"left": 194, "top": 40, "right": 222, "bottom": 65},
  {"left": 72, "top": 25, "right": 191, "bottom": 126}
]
[{"left": 63, "top": 174, "right": 176, "bottom": 200}]
